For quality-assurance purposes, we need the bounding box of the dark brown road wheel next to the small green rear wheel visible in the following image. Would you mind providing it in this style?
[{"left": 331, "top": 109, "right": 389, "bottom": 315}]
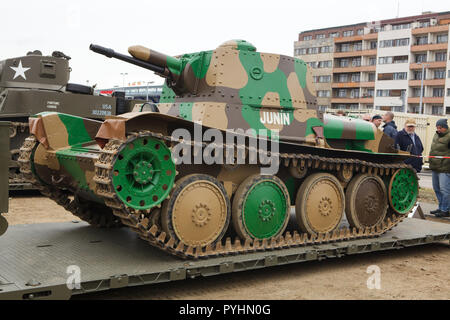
[{"left": 345, "top": 174, "right": 388, "bottom": 228}]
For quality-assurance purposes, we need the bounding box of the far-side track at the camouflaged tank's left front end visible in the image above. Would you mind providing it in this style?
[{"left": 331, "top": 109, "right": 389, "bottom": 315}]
[{"left": 19, "top": 136, "right": 123, "bottom": 228}]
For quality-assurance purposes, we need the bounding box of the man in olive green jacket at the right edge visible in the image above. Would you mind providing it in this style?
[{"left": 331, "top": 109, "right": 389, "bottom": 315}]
[{"left": 430, "top": 119, "right": 450, "bottom": 217}]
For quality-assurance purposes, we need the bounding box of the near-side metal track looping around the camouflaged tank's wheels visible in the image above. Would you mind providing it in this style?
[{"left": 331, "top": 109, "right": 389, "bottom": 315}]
[{"left": 94, "top": 131, "right": 416, "bottom": 259}]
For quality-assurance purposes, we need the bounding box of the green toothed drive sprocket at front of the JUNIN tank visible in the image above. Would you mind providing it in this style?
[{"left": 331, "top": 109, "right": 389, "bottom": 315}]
[{"left": 112, "top": 136, "right": 176, "bottom": 210}]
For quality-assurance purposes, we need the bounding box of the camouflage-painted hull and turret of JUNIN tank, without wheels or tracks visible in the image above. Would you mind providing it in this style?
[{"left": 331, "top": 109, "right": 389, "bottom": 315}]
[{"left": 23, "top": 40, "right": 408, "bottom": 201}]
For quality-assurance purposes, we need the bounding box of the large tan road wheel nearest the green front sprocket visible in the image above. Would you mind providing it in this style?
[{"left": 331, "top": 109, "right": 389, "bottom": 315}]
[{"left": 161, "top": 174, "right": 231, "bottom": 246}]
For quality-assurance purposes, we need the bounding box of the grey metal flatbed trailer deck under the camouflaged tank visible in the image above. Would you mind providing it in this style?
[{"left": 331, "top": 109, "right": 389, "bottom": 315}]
[{"left": 0, "top": 212, "right": 450, "bottom": 299}]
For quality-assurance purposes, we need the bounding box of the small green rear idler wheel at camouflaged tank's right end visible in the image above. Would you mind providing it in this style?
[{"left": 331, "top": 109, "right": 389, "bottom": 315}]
[{"left": 389, "top": 169, "right": 419, "bottom": 214}]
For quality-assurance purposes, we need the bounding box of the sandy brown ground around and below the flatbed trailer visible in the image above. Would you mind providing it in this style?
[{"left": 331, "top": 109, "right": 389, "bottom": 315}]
[{"left": 5, "top": 182, "right": 450, "bottom": 300}]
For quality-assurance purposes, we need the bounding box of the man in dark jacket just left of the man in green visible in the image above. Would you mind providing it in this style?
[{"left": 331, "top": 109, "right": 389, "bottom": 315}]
[{"left": 394, "top": 118, "right": 423, "bottom": 172}]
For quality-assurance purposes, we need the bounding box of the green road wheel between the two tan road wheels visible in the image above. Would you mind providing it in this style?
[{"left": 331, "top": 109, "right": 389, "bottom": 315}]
[{"left": 232, "top": 175, "right": 291, "bottom": 239}]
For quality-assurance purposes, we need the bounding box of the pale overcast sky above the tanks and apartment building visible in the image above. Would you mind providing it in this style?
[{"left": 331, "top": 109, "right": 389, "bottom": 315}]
[{"left": 0, "top": 0, "right": 450, "bottom": 88}]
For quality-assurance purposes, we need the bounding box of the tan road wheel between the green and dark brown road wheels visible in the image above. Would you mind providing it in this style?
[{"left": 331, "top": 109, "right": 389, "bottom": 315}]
[{"left": 295, "top": 173, "right": 345, "bottom": 235}]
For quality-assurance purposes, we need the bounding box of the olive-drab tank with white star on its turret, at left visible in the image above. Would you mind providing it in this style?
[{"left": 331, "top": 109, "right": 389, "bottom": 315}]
[{"left": 0, "top": 50, "right": 144, "bottom": 189}]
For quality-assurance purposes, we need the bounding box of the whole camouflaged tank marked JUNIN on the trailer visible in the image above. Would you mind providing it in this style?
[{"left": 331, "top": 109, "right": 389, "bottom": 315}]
[{"left": 20, "top": 40, "right": 418, "bottom": 258}]
